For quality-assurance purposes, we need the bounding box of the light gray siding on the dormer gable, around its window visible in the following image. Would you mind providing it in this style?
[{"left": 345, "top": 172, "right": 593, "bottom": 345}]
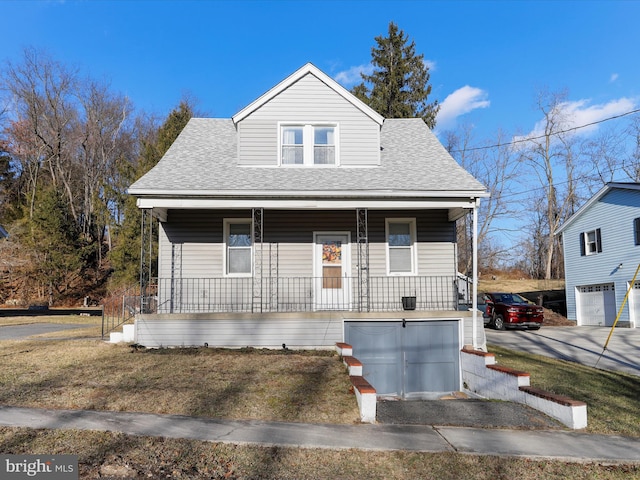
[{"left": 238, "top": 74, "right": 380, "bottom": 166}]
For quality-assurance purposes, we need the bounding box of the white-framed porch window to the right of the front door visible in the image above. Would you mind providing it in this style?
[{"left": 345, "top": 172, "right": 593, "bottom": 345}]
[{"left": 386, "top": 218, "right": 416, "bottom": 275}]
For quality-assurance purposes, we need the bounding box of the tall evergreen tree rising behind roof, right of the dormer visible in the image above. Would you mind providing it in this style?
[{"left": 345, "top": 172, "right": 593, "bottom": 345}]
[{"left": 352, "top": 22, "right": 440, "bottom": 128}]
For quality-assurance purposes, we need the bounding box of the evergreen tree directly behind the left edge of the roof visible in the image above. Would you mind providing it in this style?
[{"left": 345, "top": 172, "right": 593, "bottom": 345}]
[{"left": 109, "top": 100, "right": 194, "bottom": 285}]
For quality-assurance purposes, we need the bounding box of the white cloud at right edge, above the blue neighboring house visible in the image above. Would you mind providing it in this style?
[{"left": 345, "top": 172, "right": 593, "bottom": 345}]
[{"left": 512, "top": 97, "right": 638, "bottom": 142}]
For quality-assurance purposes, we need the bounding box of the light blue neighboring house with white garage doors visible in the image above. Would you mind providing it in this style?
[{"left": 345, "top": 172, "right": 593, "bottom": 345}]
[{"left": 558, "top": 183, "right": 640, "bottom": 327}]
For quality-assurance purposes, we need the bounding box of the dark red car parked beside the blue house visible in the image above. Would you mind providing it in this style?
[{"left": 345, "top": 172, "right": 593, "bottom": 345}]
[{"left": 482, "top": 292, "right": 544, "bottom": 330}]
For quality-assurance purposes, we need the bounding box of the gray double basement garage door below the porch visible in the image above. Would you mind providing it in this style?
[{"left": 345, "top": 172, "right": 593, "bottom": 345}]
[{"left": 345, "top": 320, "right": 461, "bottom": 398}]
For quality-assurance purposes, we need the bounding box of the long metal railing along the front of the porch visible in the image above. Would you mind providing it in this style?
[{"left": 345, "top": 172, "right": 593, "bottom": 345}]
[{"left": 142, "top": 276, "right": 458, "bottom": 313}]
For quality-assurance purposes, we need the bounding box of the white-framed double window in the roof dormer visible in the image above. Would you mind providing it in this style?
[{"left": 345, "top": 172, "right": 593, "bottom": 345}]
[{"left": 280, "top": 124, "right": 338, "bottom": 166}]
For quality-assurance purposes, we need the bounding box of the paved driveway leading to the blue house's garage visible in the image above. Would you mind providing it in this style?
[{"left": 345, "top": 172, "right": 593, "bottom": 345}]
[{"left": 485, "top": 327, "right": 640, "bottom": 376}]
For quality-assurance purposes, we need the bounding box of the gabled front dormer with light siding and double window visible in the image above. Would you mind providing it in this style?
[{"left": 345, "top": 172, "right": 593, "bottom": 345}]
[{"left": 233, "top": 64, "right": 384, "bottom": 168}]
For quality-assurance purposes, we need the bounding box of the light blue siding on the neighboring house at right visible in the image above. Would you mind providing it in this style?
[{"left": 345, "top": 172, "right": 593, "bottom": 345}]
[{"left": 562, "top": 189, "right": 640, "bottom": 322}]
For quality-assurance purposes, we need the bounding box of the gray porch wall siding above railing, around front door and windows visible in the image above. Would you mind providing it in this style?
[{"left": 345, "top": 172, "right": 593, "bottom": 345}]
[{"left": 158, "top": 210, "right": 456, "bottom": 278}]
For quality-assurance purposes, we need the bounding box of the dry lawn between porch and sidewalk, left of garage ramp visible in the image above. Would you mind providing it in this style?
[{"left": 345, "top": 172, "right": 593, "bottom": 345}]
[{"left": 0, "top": 340, "right": 359, "bottom": 423}]
